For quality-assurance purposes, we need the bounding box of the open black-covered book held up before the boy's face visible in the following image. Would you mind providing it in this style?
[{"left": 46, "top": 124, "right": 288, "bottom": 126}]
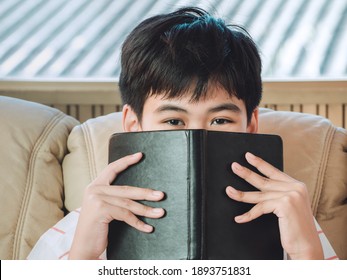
[{"left": 107, "top": 130, "right": 283, "bottom": 260}]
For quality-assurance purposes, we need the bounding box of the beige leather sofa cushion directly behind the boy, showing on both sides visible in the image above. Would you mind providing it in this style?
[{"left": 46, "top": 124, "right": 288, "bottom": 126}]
[{"left": 63, "top": 109, "right": 347, "bottom": 259}]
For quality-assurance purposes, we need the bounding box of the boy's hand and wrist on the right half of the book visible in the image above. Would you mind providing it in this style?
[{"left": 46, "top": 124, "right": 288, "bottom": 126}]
[{"left": 226, "top": 153, "right": 323, "bottom": 259}]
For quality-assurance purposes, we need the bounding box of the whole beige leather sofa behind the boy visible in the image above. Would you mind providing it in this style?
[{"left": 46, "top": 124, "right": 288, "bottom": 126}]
[{"left": 0, "top": 96, "right": 347, "bottom": 259}]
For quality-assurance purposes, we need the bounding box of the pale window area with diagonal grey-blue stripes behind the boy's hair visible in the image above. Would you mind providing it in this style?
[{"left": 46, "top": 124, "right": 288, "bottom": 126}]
[{"left": 0, "top": 0, "right": 347, "bottom": 79}]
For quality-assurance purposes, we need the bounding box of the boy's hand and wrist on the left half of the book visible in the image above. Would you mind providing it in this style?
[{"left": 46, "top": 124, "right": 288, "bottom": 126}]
[{"left": 69, "top": 153, "right": 164, "bottom": 259}]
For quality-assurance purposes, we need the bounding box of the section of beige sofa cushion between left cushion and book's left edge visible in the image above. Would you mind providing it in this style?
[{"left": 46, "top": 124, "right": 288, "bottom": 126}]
[{"left": 63, "top": 113, "right": 122, "bottom": 211}]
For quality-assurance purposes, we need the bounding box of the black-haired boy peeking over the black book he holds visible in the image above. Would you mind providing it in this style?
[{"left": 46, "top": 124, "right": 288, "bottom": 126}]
[{"left": 28, "top": 8, "right": 338, "bottom": 259}]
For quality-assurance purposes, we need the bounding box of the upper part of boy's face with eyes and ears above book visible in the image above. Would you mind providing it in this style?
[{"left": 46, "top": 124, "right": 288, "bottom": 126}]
[{"left": 123, "top": 88, "right": 258, "bottom": 133}]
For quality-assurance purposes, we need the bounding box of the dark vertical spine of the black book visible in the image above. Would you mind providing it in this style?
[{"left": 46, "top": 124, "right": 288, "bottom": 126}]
[{"left": 187, "top": 130, "right": 205, "bottom": 260}]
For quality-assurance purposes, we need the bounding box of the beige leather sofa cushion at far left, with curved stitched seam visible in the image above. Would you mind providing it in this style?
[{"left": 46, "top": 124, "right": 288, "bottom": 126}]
[{"left": 0, "top": 96, "right": 78, "bottom": 259}]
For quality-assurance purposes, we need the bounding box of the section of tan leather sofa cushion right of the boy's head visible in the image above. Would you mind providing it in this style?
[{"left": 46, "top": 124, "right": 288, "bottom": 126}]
[{"left": 259, "top": 109, "right": 347, "bottom": 259}]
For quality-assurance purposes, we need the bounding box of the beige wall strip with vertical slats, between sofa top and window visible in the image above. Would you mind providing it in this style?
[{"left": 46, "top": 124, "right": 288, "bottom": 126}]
[{"left": 0, "top": 79, "right": 347, "bottom": 128}]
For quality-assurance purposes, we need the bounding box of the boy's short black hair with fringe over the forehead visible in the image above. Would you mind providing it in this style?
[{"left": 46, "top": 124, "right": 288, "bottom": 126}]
[{"left": 119, "top": 7, "right": 262, "bottom": 121}]
